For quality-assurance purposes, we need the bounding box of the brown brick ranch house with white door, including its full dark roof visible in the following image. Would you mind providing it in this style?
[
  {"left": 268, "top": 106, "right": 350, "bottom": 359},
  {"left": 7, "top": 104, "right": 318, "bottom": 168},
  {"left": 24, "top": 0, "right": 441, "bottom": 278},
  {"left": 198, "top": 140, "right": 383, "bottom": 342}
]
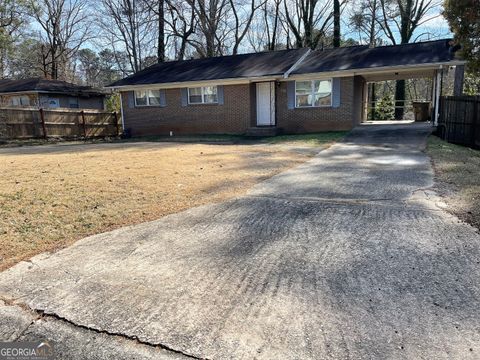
[{"left": 110, "top": 39, "right": 464, "bottom": 136}]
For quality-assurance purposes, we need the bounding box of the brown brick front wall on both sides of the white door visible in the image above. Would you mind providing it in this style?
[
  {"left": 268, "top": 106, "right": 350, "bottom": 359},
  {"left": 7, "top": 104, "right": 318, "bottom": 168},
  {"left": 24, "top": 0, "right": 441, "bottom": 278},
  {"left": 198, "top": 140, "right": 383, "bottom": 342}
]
[{"left": 122, "top": 77, "right": 359, "bottom": 136}]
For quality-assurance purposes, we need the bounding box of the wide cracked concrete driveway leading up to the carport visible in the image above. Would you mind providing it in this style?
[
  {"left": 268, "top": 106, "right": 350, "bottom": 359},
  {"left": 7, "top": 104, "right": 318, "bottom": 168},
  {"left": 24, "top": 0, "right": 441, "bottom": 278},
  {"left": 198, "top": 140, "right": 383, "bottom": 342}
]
[{"left": 0, "top": 124, "right": 480, "bottom": 359}]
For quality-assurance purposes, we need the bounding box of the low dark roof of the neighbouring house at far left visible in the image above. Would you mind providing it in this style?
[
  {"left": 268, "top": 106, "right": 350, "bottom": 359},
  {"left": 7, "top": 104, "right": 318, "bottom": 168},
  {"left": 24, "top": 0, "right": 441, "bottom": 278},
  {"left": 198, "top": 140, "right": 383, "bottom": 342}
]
[{"left": 0, "top": 78, "right": 105, "bottom": 96}]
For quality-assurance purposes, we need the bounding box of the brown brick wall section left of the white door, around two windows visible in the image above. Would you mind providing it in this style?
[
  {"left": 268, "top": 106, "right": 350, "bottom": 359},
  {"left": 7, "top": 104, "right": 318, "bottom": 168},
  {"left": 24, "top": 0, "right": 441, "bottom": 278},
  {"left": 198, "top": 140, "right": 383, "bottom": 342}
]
[{"left": 122, "top": 84, "right": 251, "bottom": 136}]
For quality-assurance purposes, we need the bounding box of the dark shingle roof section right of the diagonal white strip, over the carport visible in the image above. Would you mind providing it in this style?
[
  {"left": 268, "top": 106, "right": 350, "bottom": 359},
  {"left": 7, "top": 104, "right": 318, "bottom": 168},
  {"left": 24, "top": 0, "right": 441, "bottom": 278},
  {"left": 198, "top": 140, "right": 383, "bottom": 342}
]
[{"left": 292, "top": 40, "right": 453, "bottom": 74}]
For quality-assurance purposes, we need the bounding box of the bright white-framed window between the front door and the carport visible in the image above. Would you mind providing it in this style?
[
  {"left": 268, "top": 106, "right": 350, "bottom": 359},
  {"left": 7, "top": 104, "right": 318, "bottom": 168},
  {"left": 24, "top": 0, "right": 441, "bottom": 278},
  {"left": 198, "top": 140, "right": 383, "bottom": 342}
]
[{"left": 295, "top": 80, "right": 332, "bottom": 107}]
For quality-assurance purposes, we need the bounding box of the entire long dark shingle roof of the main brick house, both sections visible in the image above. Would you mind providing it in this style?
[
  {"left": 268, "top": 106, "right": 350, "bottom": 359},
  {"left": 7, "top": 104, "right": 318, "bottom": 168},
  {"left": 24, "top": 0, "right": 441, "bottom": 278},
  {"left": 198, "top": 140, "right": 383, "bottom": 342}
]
[{"left": 109, "top": 39, "right": 462, "bottom": 87}]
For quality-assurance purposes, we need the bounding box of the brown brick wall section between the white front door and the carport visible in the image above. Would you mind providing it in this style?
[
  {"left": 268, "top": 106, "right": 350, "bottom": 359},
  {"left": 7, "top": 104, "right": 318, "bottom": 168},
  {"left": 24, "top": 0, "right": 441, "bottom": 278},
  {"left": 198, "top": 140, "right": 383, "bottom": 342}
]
[{"left": 277, "top": 77, "right": 354, "bottom": 134}]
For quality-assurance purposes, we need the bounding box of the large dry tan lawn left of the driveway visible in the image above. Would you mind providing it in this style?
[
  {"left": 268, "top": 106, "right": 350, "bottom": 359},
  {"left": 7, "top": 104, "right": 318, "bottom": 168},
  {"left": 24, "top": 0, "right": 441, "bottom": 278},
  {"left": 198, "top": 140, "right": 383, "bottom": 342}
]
[{"left": 0, "top": 143, "right": 330, "bottom": 269}]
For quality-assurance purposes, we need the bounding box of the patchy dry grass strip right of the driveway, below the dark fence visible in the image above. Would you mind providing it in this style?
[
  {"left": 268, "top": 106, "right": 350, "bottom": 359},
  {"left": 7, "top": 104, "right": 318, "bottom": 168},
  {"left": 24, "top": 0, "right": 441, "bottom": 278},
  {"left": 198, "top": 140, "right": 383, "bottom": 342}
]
[{"left": 427, "top": 136, "right": 480, "bottom": 229}]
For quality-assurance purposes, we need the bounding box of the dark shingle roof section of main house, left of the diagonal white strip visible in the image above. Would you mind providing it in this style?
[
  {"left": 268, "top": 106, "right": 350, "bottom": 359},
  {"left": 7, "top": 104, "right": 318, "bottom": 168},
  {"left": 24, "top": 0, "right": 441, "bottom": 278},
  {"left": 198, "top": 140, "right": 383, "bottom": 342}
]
[{"left": 109, "top": 49, "right": 307, "bottom": 86}]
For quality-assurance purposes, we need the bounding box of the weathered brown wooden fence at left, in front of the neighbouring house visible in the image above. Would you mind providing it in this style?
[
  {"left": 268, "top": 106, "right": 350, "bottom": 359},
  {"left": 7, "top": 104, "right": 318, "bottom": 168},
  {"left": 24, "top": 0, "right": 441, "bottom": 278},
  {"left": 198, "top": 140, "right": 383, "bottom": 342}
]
[{"left": 0, "top": 107, "right": 121, "bottom": 139}]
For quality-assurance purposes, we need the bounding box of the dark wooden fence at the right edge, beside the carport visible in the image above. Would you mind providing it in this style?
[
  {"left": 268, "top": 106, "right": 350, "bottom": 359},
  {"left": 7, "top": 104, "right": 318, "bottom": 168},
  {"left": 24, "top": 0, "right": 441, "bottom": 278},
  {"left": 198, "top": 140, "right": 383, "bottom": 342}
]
[{"left": 437, "top": 96, "right": 480, "bottom": 148}]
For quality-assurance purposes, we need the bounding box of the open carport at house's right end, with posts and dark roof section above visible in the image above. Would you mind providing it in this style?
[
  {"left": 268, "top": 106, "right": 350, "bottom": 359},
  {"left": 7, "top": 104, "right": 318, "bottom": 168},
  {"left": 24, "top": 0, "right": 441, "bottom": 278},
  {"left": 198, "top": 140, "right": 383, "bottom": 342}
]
[{"left": 289, "top": 39, "right": 465, "bottom": 125}]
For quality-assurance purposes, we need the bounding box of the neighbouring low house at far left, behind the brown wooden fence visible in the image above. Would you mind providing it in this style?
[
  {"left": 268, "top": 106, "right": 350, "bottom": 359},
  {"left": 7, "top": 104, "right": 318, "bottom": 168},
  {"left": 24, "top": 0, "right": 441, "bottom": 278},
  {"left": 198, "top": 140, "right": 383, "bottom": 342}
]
[{"left": 0, "top": 78, "right": 106, "bottom": 110}]
